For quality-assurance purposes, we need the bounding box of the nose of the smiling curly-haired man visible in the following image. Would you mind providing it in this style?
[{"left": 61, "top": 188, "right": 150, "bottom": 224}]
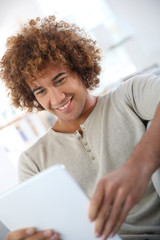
[{"left": 49, "top": 88, "right": 65, "bottom": 107}]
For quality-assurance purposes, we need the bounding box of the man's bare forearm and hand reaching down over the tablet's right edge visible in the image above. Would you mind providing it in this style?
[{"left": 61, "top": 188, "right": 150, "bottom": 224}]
[{"left": 89, "top": 103, "right": 160, "bottom": 239}]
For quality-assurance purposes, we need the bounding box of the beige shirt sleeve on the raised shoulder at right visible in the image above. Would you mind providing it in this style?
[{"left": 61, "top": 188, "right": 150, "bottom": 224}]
[{"left": 116, "top": 74, "right": 160, "bottom": 120}]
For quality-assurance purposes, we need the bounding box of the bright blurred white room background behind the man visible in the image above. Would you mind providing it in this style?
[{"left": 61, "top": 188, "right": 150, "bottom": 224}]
[{"left": 0, "top": 0, "right": 160, "bottom": 194}]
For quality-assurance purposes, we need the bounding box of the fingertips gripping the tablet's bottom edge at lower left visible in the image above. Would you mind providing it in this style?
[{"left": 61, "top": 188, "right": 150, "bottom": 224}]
[{"left": 6, "top": 228, "right": 60, "bottom": 240}]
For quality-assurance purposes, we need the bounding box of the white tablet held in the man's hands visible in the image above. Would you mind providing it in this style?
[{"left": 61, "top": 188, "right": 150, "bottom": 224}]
[{"left": 0, "top": 165, "right": 120, "bottom": 240}]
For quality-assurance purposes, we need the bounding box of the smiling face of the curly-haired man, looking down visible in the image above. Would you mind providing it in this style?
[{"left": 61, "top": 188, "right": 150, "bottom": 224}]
[{"left": 27, "top": 64, "right": 90, "bottom": 121}]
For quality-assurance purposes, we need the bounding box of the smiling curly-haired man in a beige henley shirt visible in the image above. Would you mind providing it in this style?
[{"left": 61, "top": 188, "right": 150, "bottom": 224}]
[{"left": 1, "top": 17, "right": 160, "bottom": 240}]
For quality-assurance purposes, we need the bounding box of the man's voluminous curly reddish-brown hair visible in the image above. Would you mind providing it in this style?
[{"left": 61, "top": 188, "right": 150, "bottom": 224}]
[{"left": 0, "top": 16, "right": 101, "bottom": 112}]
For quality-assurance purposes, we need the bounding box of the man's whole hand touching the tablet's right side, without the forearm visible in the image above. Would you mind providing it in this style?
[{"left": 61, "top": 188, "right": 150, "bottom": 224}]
[{"left": 89, "top": 162, "right": 150, "bottom": 239}]
